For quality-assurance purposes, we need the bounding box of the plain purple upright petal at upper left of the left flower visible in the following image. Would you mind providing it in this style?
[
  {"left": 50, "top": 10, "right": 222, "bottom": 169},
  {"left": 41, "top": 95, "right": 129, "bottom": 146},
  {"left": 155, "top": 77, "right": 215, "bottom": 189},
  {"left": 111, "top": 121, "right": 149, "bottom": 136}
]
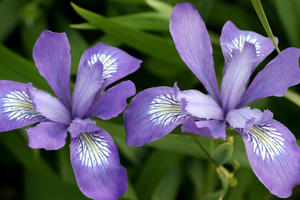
[{"left": 33, "top": 31, "right": 71, "bottom": 108}]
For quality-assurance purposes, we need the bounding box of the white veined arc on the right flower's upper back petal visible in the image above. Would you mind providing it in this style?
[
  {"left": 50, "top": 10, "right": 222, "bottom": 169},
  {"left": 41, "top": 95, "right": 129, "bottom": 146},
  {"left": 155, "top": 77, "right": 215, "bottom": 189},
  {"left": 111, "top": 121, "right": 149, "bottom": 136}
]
[{"left": 226, "top": 33, "right": 263, "bottom": 58}]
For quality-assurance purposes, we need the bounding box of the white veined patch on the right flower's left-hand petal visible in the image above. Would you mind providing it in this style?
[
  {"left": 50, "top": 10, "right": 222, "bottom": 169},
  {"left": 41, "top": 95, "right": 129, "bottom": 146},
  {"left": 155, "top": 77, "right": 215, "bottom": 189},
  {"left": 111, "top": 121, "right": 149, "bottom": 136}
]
[{"left": 148, "top": 94, "right": 186, "bottom": 127}]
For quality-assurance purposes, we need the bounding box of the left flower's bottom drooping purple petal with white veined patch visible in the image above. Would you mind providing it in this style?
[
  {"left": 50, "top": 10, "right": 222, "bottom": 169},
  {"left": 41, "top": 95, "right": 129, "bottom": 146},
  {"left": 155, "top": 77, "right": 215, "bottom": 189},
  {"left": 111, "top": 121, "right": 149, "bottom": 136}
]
[{"left": 71, "top": 119, "right": 127, "bottom": 200}]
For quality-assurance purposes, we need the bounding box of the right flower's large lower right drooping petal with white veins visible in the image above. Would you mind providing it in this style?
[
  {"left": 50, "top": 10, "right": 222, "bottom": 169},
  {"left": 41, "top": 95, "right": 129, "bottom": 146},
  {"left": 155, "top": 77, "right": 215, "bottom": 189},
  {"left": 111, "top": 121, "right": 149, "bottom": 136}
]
[{"left": 242, "top": 120, "right": 300, "bottom": 198}]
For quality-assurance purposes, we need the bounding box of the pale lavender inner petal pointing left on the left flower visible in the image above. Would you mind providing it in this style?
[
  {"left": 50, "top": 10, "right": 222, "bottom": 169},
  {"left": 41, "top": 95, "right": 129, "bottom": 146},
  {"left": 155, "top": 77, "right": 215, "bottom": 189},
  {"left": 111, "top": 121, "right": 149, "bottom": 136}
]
[{"left": 29, "top": 87, "right": 71, "bottom": 125}]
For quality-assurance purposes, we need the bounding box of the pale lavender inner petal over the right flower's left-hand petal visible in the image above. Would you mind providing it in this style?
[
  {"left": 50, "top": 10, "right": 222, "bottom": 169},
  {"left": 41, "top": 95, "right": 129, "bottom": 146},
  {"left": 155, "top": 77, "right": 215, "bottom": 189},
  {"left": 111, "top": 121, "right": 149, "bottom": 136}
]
[{"left": 177, "top": 90, "right": 224, "bottom": 120}]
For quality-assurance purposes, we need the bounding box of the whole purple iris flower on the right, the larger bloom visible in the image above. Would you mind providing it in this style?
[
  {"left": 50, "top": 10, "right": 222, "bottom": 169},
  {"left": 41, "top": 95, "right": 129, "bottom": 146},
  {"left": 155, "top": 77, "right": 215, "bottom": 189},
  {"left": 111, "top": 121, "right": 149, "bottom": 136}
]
[{"left": 124, "top": 3, "right": 300, "bottom": 197}]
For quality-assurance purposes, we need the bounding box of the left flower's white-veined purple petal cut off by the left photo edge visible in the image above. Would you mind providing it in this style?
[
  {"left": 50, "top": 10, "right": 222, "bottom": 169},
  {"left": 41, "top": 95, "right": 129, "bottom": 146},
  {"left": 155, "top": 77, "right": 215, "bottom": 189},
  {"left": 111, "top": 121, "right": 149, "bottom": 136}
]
[{"left": 0, "top": 81, "right": 44, "bottom": 132}]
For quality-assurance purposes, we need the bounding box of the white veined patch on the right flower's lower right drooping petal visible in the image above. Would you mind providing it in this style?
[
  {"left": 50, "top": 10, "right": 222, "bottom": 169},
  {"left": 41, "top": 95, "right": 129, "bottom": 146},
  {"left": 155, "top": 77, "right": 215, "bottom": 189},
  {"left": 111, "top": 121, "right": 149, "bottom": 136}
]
[{"left": 247, "top": 124, "right": 285, "bottom": 160}]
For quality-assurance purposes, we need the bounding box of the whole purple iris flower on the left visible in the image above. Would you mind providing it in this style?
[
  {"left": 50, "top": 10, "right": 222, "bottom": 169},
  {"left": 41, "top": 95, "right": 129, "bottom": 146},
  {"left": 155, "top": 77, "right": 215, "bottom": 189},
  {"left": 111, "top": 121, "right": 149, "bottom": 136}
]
[{"left": 0, "top": 31, "right": 141, "bottom": 200}]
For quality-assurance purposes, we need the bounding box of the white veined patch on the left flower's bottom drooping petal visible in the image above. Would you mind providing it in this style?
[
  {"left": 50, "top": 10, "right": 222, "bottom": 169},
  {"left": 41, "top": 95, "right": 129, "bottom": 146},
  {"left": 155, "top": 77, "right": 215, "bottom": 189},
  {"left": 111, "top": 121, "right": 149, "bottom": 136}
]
[{"left": 75, "top": 133, "right": 111, "bottom": 168}]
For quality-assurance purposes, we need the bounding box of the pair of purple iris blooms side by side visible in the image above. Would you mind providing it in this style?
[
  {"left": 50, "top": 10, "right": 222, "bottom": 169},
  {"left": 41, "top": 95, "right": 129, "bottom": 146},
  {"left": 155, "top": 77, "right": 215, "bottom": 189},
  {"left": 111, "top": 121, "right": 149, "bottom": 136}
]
[{"left": 0, "top": 3, "right": 300, "bottom": 200}]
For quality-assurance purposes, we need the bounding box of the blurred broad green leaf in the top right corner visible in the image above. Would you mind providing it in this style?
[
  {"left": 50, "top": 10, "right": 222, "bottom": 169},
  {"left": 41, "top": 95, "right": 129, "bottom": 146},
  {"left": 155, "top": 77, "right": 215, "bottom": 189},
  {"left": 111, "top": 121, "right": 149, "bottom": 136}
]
[{"left": 274, "top": 0, "right": 300, "bottom": 47}]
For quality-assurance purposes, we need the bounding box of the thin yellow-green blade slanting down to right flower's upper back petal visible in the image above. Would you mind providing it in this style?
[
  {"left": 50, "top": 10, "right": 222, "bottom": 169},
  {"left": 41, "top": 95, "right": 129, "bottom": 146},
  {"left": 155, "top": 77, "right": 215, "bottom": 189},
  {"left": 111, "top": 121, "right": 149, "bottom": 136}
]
[{"left": 251, "top": 0, "right": 280, "bottom": 53}]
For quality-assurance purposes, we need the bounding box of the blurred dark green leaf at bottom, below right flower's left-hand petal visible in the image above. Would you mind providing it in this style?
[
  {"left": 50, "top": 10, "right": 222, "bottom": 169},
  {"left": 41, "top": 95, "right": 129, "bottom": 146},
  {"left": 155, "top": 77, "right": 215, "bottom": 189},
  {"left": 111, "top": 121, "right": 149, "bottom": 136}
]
[{"left": 136, "top": 150, "right": 183, "bottom": 200}]
